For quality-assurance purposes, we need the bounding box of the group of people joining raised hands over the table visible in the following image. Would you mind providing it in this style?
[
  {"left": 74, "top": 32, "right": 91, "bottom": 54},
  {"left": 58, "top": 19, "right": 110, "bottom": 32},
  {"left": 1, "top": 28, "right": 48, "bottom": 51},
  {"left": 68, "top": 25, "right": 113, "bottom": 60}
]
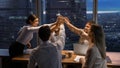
[{"left": 9, "top": 14, "right": 107, "bottom": 68}]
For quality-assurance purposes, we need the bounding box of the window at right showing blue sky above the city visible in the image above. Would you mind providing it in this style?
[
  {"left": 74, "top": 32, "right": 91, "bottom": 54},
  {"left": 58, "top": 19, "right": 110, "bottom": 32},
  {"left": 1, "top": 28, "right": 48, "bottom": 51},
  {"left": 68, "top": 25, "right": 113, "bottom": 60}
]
[{"left": 87, "top": 0, "right": 120, "bottom": 51}]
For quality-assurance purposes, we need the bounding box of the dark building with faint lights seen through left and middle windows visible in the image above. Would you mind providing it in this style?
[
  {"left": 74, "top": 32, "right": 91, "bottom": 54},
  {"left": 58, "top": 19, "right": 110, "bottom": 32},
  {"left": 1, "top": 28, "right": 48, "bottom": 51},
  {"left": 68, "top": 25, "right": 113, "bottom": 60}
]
[{"left": 0, "top": 0, "right": 86, "bottom": 49}]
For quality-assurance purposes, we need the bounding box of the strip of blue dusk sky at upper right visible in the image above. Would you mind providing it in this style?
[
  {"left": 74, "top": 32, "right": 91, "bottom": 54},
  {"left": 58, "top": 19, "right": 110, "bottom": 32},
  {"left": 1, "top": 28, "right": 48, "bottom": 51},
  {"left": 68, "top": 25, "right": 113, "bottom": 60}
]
[{"left": 87, "top": 0, "right": 120, "bottom": 11}]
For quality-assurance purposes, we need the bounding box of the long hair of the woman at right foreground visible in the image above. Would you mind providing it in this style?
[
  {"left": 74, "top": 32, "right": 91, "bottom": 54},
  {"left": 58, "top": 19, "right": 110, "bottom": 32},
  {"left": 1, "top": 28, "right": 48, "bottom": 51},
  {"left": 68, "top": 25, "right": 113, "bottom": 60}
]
[{"left": 91, "top": 24, "right": 106, "bottom": 59}]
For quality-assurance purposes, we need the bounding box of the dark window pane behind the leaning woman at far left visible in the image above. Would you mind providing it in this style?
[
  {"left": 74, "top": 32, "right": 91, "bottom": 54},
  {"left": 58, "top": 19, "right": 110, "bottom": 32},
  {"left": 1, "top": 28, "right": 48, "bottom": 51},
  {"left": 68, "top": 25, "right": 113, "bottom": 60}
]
[{"left": 0, "top": 0, "right": 36, "bottom": 48}]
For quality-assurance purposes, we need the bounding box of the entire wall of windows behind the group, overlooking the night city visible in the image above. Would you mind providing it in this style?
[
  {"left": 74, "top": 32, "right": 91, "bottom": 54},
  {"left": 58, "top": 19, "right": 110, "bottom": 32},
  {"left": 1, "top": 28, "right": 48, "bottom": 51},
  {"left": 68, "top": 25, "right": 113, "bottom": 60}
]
[{"left": 0, "top": 0, "right": 120, "bottom": 51}]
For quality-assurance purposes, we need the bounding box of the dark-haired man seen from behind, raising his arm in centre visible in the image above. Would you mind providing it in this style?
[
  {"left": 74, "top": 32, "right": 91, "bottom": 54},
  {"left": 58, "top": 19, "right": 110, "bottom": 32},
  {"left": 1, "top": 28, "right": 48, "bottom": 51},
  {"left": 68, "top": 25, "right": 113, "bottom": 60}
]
[{"left": 28, "top": 17, "right": 65, "bottom": 68}]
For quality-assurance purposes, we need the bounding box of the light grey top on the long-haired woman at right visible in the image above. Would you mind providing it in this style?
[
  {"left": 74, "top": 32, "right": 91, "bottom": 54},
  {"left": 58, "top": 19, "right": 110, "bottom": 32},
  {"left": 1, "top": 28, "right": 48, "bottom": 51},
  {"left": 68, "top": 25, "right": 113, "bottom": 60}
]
[{"left": 84, "top": 46, "right": 107, "bottom": 68}]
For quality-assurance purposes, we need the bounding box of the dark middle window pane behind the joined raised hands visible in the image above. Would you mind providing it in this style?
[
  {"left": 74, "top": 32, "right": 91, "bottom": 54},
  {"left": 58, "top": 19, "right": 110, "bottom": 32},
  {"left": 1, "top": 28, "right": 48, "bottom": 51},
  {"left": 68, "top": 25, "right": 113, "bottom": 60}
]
[{"left": 42, "top": 0, "right": 87, "bottom": 49}]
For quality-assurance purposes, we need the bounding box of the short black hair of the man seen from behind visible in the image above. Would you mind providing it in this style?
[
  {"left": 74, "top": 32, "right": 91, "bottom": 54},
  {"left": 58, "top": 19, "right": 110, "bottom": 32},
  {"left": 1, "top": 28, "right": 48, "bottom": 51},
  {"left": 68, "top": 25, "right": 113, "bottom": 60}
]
[{"left": 38, "top": 26, "right": 51, "bottom": 41}]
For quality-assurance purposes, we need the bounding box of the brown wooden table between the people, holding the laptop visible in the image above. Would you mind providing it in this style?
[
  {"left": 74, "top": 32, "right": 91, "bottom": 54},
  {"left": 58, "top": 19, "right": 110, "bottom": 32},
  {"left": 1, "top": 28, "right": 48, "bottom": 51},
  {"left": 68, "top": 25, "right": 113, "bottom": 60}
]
[{"left": 12, "top": 50, "right": 84, "bottom": 68}]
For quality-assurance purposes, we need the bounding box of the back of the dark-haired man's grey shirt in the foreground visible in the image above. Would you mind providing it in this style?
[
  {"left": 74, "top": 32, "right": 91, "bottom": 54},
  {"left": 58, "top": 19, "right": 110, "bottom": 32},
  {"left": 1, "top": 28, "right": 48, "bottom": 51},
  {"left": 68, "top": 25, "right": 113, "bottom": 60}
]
[{"left": 29, "top": 42, "right": 59, "bottom": 68}]
